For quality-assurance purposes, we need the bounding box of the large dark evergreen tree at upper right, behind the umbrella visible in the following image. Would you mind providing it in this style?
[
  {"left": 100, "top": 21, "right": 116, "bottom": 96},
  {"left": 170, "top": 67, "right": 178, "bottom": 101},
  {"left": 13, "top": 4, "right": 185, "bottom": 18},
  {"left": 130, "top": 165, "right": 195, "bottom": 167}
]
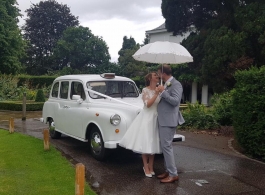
[{"left": 162, "top": 0, "right": 265, "bottom": 93}]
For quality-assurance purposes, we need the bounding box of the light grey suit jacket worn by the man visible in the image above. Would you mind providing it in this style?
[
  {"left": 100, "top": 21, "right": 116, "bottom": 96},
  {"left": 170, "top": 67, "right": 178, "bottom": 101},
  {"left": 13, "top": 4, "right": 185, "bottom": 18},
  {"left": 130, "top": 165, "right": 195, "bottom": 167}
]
[{"left": 157, "top": 78, "right": 185, "bottom": 127}]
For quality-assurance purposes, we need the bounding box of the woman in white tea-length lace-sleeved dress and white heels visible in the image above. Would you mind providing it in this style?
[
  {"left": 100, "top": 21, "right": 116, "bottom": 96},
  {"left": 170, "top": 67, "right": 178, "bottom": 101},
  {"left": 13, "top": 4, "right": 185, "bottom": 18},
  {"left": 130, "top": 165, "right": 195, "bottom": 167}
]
[{"left": 119, "top": 72, "right": 162, "bottom": 177}]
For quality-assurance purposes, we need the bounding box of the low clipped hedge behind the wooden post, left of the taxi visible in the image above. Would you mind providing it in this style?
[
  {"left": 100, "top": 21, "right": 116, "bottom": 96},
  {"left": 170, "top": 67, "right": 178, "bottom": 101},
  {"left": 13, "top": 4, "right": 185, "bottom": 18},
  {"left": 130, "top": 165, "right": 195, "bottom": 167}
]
[{"left": 0, "top": 101, "right": 44, "bottom": 111}]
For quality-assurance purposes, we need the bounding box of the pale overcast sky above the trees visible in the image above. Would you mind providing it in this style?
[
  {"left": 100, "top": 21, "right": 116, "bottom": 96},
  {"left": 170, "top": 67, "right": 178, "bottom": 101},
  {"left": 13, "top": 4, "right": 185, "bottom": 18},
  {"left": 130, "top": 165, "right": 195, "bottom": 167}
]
[{"left": 17, "top": 0, "right": 165, "bottom": 62}]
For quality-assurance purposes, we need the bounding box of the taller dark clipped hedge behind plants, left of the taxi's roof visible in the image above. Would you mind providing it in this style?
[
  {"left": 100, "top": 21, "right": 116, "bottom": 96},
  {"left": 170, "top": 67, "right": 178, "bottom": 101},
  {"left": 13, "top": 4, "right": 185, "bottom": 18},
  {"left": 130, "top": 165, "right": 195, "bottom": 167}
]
[{"left": 17, "top": 75, "right": 57, "bottom": 88}]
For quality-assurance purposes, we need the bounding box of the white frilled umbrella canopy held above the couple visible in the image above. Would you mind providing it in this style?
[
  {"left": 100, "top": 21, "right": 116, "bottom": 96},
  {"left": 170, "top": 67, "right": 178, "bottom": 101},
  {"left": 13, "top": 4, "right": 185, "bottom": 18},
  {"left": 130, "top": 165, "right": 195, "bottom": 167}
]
[{"left": 133, "top": 41, "right": 193, "bottom": 64}]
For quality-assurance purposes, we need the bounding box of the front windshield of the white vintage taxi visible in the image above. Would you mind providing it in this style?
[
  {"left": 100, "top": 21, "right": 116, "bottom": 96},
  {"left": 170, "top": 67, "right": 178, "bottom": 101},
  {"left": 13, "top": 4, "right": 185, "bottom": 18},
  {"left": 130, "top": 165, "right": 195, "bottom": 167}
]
[{"left": 87, "top": 81, "right": 139, "bottom": 99}]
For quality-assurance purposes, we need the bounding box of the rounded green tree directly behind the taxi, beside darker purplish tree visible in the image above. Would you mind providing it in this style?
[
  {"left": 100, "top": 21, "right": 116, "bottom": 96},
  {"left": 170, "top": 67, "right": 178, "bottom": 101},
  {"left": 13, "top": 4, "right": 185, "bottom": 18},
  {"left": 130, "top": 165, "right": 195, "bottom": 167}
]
[{"left": 54, "top": 26, "right": 110, "bottom": 72}]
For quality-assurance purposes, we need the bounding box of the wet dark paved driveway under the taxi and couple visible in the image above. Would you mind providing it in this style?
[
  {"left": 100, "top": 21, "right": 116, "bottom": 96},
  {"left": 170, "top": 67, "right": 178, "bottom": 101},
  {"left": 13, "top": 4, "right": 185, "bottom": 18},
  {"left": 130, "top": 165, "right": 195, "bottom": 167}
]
[{"left": 0, "top": 116, "right": 265, "bottom": 195}]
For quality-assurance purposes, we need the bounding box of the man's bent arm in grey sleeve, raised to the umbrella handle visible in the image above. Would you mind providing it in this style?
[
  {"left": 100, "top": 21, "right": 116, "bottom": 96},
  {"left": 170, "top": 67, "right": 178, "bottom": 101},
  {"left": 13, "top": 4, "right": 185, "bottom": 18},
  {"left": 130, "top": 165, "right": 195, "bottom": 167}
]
[{"left": 161, "top": 82, "right": 183, "bottom": 106}]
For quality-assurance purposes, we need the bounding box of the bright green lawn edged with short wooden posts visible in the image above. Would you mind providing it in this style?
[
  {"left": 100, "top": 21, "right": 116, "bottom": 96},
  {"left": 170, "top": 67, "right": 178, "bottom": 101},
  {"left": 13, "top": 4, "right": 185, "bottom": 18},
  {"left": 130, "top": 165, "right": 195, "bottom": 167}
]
[{"left": 0, "top": 129, "right": 96, "bottom": 195}]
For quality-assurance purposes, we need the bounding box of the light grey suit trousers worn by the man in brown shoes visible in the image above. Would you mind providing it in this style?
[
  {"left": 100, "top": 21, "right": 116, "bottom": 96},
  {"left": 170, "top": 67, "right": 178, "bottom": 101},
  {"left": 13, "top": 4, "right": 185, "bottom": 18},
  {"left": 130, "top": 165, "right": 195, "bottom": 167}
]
[{"left": 158, "top": 124, "right": 178, "bottom": 177}]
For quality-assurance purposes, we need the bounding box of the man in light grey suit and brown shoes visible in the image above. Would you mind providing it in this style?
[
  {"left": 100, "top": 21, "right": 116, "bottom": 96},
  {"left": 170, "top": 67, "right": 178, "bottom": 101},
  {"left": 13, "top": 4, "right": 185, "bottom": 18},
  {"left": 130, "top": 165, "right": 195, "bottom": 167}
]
[{"left": 157, "top": 64, "right": 185, "bottom": 183}]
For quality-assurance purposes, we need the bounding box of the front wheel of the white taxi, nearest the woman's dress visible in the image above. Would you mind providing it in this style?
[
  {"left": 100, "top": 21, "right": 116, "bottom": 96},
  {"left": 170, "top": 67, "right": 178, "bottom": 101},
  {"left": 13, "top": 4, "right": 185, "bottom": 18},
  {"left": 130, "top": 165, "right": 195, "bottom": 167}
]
[{"left": 89, "top": 127, "right": 109, "bottom": 161}]
